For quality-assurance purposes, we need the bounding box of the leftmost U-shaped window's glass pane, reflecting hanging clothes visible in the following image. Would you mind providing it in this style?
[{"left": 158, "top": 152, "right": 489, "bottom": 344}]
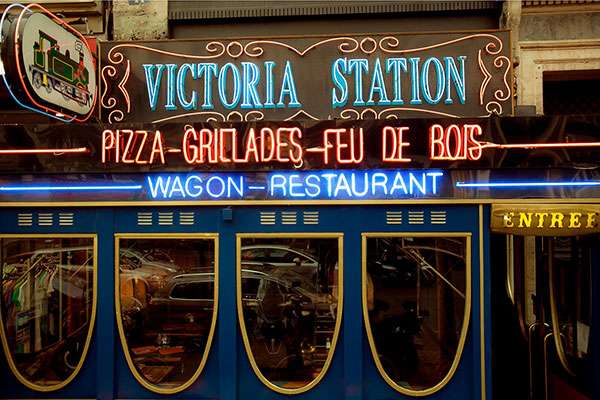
[{"left": 0, "top": 236, "right": 95, "bottom": 390}]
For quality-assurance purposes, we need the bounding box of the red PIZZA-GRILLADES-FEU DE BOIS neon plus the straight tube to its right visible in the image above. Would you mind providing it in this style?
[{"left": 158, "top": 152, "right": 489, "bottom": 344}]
[{"left": 92, "top": 121, "right": 600, "bottom": 169}]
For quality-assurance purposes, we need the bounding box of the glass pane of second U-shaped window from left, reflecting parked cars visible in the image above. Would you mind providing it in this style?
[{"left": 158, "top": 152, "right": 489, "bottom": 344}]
[{"left": 118, "top": 238, "right": 216, "bottom": 393}]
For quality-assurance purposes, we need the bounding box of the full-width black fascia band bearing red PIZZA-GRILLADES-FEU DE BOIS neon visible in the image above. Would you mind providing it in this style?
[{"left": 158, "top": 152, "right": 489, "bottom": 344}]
[{"left": 0, "top": 117, "right": 600, "bottom": 173}]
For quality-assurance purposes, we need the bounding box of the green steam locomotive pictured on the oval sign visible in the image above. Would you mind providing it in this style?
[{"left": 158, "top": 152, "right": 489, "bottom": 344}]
[{"left": 29, "top": 31, "right": 92, "bottom": 106}]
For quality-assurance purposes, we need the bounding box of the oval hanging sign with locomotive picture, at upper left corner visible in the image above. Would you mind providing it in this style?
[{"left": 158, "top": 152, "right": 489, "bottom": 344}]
[{"left": 2, "top": 4, "right": 97, "bottom": 122}]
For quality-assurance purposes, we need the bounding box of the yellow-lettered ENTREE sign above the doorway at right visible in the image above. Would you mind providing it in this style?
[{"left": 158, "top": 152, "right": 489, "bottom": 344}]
[{"left": 491, "top": 204, "right": 600, "bottom": 236}]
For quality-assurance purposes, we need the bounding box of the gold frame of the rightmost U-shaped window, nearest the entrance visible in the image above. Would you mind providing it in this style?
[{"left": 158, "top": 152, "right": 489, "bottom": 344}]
[{"left": 361, "top": 232, "right": 474, "bottom": 397}]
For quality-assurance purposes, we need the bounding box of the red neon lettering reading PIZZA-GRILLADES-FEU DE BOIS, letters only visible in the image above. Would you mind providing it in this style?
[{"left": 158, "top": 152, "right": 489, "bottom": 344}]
[{"left": 101, "top": 124, "right": 484, "bottom": 167}]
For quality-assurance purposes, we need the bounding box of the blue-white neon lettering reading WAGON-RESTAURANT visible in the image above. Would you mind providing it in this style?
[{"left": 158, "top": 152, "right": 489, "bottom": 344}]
[{"left": 145, "top": 170, "right": 444, "bottom": 200}]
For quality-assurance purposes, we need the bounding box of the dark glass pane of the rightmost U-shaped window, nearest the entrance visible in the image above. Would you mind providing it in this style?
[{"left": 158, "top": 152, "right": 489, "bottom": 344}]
[{"left": 365, "top": 236, "right": 469, "bottom": 391}]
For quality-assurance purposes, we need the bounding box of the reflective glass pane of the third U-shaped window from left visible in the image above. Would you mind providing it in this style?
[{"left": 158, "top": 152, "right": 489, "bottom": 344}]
[{"left": 238, "top": 237, "right": 341, "bottom": 392}]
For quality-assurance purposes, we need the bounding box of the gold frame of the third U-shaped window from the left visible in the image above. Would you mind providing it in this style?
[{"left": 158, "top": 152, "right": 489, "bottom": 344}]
[{"left": 236, "top": 232, "right": 344, "bottom": 395}]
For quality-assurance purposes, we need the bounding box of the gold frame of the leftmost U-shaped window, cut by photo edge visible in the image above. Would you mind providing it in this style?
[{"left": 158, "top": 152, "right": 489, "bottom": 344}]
[{"left": 0, "top": 233, "right": 98, "bottom": 392}]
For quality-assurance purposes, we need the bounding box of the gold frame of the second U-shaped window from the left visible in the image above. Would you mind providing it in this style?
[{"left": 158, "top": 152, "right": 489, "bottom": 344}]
[{"left": 114, "top": 233, "right": 219, "bottom": 395}]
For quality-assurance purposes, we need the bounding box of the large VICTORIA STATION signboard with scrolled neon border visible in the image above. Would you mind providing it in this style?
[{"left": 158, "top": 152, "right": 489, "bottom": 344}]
[{"left": 100, "top": 31, "right": 512, "bottom": 123}]
